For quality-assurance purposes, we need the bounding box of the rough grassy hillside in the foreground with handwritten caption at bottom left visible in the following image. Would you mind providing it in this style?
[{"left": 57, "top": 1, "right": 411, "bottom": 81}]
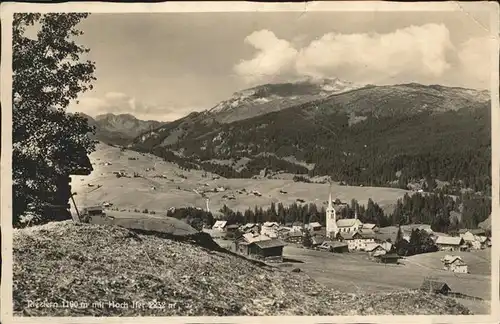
[{"left": 13, "top": 221, "right": 470, "bottom": 316}]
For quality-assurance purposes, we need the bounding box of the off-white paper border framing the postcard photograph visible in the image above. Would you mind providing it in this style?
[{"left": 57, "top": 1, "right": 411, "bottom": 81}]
[{"left": 0, "top": 1, "right": 500, "bottom": 324}]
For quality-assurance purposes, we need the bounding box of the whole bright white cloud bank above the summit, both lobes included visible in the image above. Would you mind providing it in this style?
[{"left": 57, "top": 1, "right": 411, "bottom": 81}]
[{"left": 234, "top": 24, "right": 464, "bottom": 86}]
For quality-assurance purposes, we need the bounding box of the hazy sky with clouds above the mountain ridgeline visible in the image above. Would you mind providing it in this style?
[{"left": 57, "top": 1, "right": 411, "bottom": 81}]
[{"left": 57, "top": 11, "right": 491, "bottom": 121}]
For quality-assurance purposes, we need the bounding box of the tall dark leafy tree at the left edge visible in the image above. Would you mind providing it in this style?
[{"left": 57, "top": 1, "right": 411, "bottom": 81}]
[{"left": 12, "top": 13, "right": 95, "bottom": 226}]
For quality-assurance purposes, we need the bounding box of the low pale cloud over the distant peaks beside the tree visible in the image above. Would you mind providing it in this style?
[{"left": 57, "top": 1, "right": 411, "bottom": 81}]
[{"left": 68, "top": 92, "right": 194, "bottom": 121}]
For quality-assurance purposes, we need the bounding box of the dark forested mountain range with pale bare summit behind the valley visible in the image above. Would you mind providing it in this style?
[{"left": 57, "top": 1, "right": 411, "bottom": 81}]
[{"left": 83, "top": 79, "right": 491, "bottom": 196}]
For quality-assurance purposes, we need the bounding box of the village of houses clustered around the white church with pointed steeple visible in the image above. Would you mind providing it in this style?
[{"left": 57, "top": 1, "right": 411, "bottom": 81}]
[{"left": 203, "top": 190, "right": 492, "bottom": 274}]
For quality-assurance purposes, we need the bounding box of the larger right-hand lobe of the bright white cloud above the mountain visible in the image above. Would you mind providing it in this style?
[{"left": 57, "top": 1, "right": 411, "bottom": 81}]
[{"left": 296, "top": 24, "right": 452, "bottom": 81}]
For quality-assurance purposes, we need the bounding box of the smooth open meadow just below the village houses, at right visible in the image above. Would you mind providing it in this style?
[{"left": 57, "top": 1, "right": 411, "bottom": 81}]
[{"left": 284, "top": 245, "right": 491, "bottom": 314}]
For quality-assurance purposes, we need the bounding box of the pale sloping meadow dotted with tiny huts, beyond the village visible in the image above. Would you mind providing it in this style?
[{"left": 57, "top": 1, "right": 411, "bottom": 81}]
[{"left": 72, "top": 144, "right": 409, "bottom": 212}]
